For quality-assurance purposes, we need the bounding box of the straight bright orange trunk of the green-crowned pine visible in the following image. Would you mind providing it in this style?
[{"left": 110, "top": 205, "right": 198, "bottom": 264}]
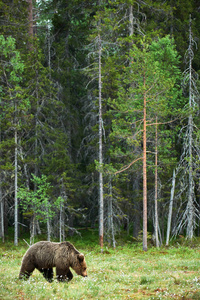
[{"left": 143, "top": 84, "right": 147, "bottom": 251}]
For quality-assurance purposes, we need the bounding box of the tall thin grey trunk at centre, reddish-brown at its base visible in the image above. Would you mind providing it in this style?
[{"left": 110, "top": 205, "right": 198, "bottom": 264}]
[{"left": 98, "top": 34, "right": 104, "bottom": 252}]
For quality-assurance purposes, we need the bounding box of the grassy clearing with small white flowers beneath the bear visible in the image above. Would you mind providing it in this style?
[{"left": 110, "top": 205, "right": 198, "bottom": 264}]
[{"left": 0, "top": 231, "right": 200, "bottom": 300}]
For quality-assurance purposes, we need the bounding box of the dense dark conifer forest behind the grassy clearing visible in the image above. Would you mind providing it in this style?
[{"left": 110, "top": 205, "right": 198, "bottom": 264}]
[{"left": 0, "top": 0, "right": 200, "bottom": 251}]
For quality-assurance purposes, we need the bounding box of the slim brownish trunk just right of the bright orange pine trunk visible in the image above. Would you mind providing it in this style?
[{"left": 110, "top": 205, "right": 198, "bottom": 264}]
[{"left": 155, "top": 117, "right": 159, "bottom": 247}]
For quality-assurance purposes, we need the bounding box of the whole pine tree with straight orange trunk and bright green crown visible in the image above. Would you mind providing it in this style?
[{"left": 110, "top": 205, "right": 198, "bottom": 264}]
[{"left": 110, "top": 37, "right": 180, "bottom": 251}]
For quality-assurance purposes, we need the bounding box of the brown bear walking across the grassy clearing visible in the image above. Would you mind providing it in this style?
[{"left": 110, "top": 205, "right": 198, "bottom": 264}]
[{"left": 19, "top": 241, "right": 87, "bottom": 282}]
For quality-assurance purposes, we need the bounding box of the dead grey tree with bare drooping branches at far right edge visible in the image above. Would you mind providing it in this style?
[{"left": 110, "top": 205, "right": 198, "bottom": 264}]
[{"left": 175, "top": 15, "right": 200, "bottom": 239}]
